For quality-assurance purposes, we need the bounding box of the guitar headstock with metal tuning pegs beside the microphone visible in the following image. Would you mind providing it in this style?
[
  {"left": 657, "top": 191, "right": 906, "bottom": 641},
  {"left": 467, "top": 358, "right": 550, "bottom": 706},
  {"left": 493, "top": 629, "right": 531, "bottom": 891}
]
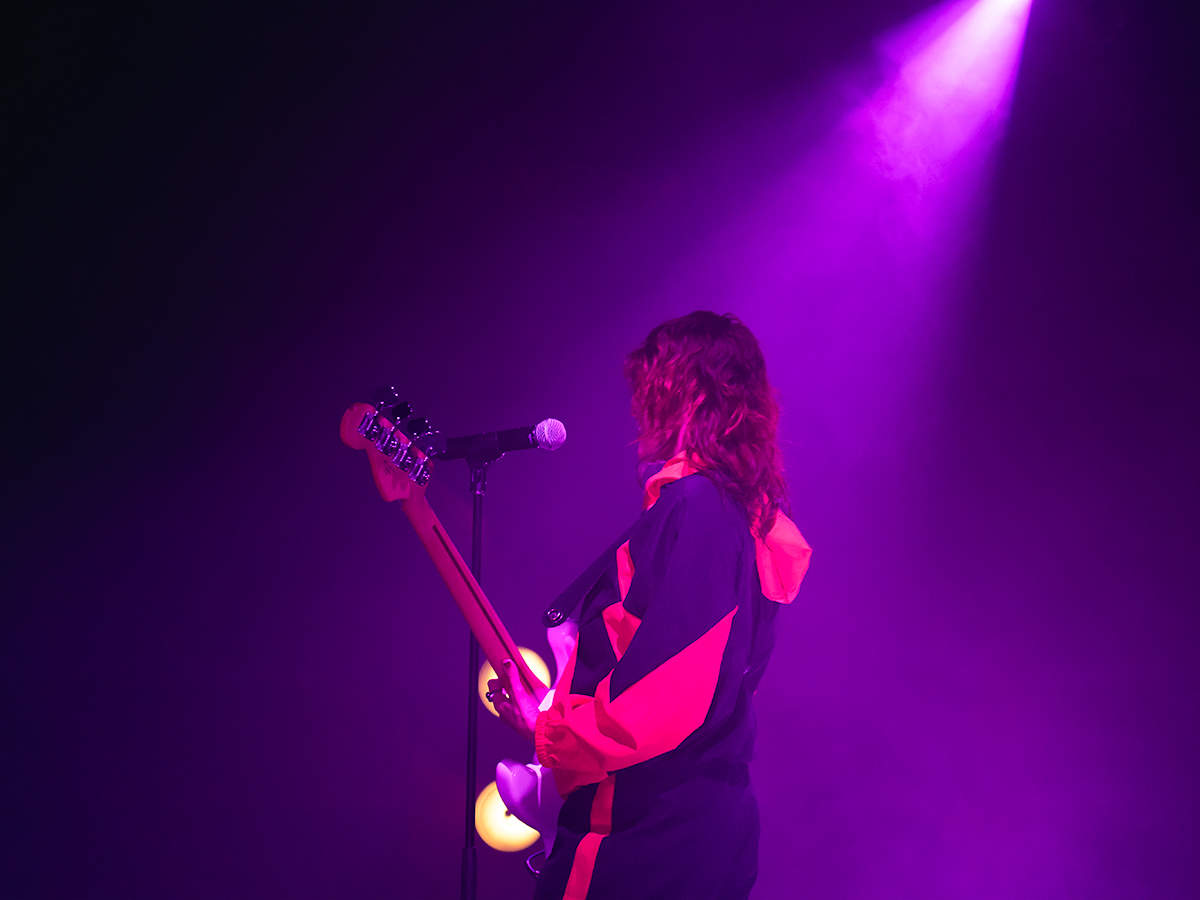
[{"left": 341, "top": 388, "right": 445, "bottom": 503}]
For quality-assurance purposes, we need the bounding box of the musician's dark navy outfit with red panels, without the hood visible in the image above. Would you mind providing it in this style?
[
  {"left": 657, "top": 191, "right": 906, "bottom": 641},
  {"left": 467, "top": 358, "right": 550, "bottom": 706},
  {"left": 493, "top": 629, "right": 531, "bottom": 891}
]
[{"left": 536, "top": 474, "right": 778, "bottom": 899}]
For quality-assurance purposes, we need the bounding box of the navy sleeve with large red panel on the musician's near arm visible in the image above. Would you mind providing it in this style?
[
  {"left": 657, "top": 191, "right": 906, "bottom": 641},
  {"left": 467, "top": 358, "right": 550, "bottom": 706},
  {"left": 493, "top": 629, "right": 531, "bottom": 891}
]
[{"left": 535, "top": 481, "right": 745, "bottom": 794}]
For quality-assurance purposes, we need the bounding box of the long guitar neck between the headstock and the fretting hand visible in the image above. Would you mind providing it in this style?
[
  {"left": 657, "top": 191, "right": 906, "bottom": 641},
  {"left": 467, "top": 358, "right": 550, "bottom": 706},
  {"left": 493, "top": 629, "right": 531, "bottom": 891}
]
[{"left": 400, "top": 492, "right": 548, "bottom": 701}]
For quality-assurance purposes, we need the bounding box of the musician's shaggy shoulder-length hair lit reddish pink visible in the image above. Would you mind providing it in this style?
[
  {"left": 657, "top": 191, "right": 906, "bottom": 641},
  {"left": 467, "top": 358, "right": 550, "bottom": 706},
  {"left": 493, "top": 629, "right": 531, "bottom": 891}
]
[{"left": 625, "top": 311, "right": 787, "bottom": 536}]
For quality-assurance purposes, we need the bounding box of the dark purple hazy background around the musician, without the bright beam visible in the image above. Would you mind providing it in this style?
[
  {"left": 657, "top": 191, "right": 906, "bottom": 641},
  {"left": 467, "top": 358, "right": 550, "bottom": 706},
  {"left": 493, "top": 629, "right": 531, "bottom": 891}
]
[{"left": 0, "top": 0, "right": 1200, "bottom": 900}]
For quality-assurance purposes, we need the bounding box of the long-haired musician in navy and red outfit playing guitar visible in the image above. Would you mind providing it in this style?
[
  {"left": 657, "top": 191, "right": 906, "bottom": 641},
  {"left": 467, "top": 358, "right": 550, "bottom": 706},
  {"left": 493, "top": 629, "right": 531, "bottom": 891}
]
[{"left": 490, "top": 312, "right": 811, "bottom": 900}]
